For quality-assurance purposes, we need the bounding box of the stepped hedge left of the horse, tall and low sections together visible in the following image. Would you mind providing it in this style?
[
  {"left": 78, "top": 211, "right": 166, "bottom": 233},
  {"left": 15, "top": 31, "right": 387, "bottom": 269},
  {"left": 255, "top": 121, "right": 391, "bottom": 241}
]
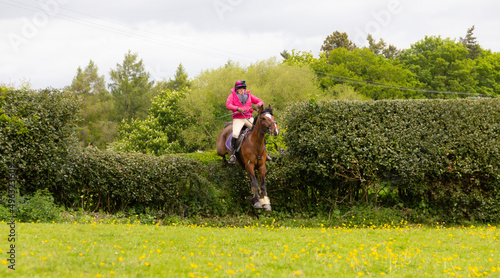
[{"left": 0, "top": 87, "right": 250, "bottom": 216}]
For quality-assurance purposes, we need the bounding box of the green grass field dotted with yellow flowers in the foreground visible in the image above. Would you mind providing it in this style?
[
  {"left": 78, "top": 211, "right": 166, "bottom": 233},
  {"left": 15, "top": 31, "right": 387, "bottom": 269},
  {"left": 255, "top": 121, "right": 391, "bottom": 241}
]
[{"left": 0, "top": 221, "right": 500, "bottom": 277}]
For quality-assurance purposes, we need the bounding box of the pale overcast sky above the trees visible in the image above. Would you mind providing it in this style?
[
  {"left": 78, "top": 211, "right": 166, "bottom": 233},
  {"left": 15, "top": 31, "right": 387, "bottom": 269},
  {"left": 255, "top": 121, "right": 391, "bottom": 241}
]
[{"left": 0, "top": 0, "right": 500, "bottom": 89}]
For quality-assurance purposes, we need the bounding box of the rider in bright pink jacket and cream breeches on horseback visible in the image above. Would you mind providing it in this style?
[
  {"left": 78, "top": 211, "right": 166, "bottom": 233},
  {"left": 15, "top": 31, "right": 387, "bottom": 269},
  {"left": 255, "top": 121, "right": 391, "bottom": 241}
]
[{"left": 226, "top": 80, "right": 264, "bottom": 164}]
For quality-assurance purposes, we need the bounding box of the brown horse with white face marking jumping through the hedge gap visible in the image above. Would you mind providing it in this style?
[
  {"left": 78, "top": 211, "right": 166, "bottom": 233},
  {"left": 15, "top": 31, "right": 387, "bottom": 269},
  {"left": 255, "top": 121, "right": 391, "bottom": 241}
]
[{"left": 217, "top": 105, "right": 279, "bottom": 211}]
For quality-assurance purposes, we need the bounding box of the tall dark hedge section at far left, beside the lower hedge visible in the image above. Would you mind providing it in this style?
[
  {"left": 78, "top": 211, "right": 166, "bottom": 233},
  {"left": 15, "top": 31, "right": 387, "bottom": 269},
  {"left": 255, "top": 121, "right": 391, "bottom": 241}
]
[{"left": 0, "top": 87, "right": 78, "bottom": 195}]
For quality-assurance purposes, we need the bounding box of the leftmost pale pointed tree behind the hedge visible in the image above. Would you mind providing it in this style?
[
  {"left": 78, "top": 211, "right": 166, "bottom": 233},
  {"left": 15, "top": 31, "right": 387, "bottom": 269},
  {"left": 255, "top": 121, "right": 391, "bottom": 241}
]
[{"left": 70, "top": 60, "right": 116, "bottom": 148}]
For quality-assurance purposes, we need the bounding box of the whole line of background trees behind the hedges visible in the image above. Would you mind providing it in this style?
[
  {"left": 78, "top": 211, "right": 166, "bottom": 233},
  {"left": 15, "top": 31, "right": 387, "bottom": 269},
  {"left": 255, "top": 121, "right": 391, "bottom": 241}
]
[{"left": 67, "top": 26, "right": 500, "bottom": 155}]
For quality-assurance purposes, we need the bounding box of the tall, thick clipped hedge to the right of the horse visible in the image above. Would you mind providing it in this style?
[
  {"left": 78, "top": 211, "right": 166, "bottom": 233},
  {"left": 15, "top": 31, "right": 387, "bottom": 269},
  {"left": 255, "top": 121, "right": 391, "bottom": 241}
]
[{"left": 283, "top": 99, "right": 500, "bottom": 221}]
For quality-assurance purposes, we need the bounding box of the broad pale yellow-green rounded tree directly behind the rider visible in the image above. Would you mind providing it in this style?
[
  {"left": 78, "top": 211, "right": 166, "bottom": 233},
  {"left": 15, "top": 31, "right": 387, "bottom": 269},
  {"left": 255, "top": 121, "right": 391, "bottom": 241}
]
[{"left": 180, "top": 59, "right": 323, "bottom": 151}]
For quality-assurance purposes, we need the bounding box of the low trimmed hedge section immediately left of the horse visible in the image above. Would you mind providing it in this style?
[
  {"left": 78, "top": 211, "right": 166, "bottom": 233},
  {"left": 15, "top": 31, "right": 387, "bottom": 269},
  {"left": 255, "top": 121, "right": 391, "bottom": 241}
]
[{"left": 52, "top": 148, "right": 232, "bottom": 216}]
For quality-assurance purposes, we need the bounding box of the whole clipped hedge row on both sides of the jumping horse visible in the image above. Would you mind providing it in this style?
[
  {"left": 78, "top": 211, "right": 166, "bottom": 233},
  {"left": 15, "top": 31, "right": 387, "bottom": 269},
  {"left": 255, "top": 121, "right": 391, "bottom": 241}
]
[{"left": 0, "top": 88, "right": 500, "bottom": 222}]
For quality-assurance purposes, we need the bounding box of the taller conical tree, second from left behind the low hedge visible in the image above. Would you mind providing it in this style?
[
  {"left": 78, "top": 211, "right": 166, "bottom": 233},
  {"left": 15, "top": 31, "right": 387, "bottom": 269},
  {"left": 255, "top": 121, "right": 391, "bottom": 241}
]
[{"left": 109, "top": 50, "right": 154, "bottom": 121}]
